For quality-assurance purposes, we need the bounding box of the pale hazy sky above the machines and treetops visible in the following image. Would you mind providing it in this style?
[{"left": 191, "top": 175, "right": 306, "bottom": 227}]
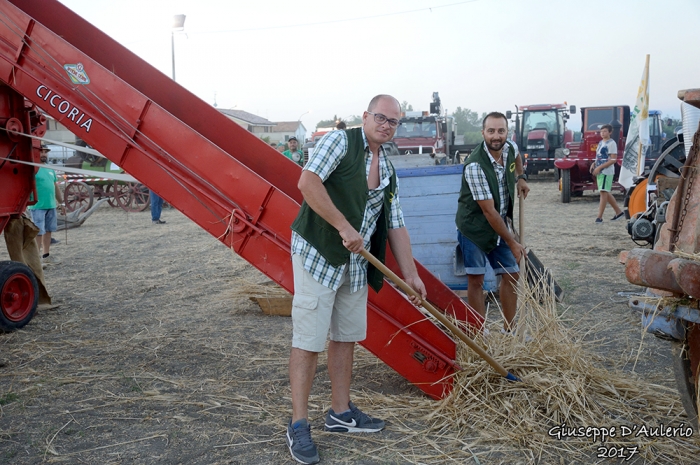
[{"left": 61, "top": 0, "right": 700, "bottom": 135}]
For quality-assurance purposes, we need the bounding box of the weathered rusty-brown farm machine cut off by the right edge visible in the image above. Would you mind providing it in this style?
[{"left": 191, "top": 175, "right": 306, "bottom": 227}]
[{"left": 621, "top": 89, "right": 700, "bottom": 426}]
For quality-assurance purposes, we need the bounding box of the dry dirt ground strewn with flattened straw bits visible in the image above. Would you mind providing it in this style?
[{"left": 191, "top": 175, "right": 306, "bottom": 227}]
[{"left": 0, "top": 176, "right": 688, "bottom": 464}]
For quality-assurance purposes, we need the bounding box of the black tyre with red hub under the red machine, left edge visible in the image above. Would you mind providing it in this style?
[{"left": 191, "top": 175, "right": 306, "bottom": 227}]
[{"left": 0, "top": 261, "right": 39, "bottom": 332}]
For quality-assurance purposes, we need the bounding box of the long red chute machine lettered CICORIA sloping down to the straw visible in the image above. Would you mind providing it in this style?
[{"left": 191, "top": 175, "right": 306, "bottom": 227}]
[{"left": 0, "top": 0, "right": 481, "bottom": 398}]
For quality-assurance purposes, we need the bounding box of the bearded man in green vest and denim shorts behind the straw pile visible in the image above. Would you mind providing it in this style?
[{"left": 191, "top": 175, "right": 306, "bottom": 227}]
[{"left": 455, "top": 112, "right": 530, "bottom": 333}]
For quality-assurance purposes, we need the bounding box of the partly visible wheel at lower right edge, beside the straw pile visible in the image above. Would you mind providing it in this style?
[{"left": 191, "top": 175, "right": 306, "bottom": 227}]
[{"left": 673, "top": 323, "right": 700, "bottom": 429}]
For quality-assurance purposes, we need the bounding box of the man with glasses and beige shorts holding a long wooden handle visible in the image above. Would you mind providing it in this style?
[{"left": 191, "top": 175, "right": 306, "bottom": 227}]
[{"left": 287, "top": 95, "right": 426, "bottom": 463}]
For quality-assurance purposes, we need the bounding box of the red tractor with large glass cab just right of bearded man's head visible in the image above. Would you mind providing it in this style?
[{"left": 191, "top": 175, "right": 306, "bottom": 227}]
[{"left": 506, "top": 103, "right": 576, "bottom": 175}]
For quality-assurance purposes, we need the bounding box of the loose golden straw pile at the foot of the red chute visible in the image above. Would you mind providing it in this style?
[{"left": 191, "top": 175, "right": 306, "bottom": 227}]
[{"left": 416, "top": 262, "right": 700, "bottom": 463}]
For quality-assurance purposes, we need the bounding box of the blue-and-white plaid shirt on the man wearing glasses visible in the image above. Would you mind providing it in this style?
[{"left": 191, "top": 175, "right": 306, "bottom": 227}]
[{"left": 292, "top": 130, "right": 404, "bottom": 292}]
